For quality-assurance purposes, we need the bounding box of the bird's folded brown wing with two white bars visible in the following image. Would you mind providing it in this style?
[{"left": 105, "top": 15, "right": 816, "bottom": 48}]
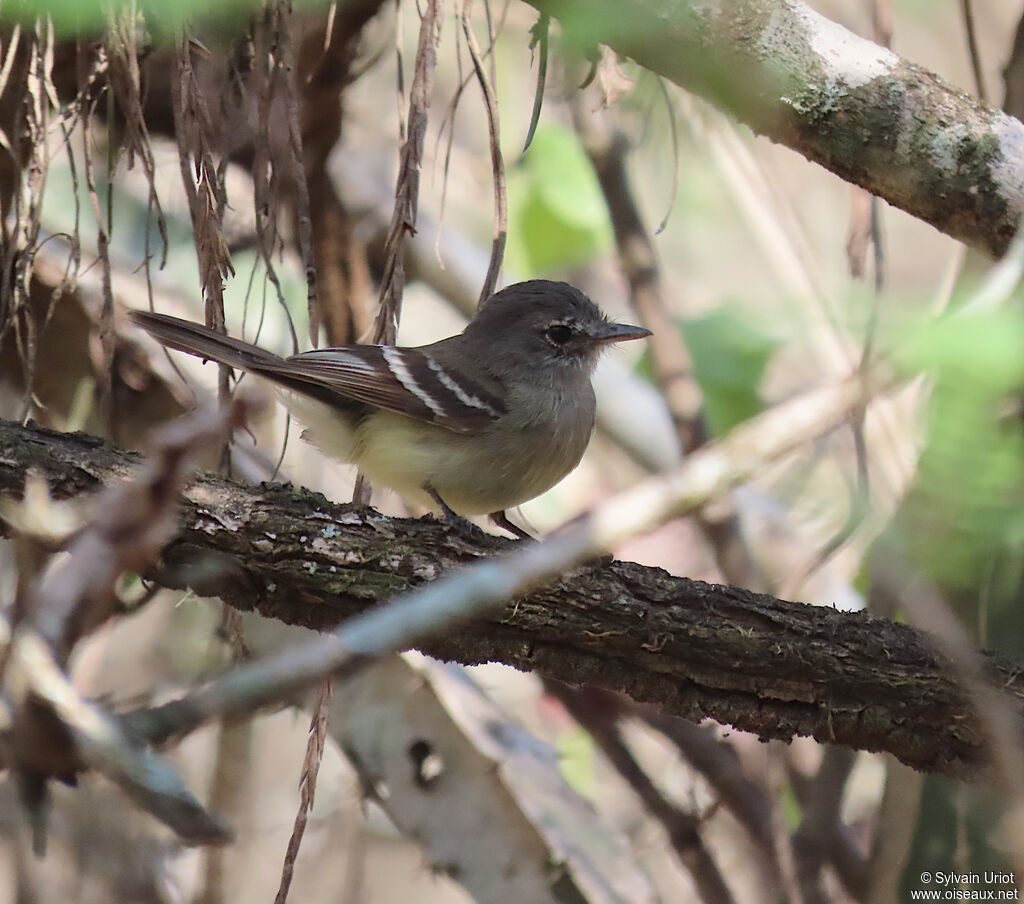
[{"left": 274, "top": 345, "right": 505, "bottom": 433}]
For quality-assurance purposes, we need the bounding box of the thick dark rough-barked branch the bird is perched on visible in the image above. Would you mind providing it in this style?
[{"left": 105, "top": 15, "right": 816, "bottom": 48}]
[{"left": 0, "top": 422, "right": 1024, "bottom": 777}]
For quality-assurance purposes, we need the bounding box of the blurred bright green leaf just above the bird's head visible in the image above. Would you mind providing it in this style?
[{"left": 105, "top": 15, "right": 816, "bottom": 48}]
[{"left": 507, "top": 125, "right": 612, "bottom": 276}]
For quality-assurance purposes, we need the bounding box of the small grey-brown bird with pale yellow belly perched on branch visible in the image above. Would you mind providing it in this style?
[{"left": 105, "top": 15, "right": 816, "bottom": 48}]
[{"left": 130, "top": 279, "right": 651, "bottom": 539}]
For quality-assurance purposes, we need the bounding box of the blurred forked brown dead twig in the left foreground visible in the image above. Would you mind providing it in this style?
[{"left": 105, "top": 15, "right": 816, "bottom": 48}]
[{"left": 0, "top": 398, "right": 262, "bottom": 850}]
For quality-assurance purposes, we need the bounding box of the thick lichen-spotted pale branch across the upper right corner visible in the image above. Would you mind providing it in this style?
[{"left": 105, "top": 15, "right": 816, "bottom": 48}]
[{"left": 528, "top": 0, "right": 1024, "bottom": 255}]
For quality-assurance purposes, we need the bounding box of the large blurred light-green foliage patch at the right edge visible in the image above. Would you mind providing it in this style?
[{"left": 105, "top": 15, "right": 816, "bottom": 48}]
[{"left": 884, "top": 310, "right": 1024, "bottom": 626}]
